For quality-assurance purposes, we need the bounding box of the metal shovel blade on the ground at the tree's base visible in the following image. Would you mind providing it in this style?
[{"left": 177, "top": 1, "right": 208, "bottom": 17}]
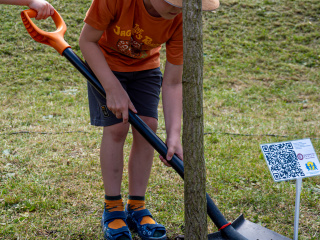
[{"left": 208, "top": 215, "right": 291, "bottom": 240}]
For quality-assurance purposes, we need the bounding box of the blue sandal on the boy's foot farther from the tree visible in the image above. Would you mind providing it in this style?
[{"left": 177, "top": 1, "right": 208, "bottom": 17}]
[{"left": 101, "top": 210, "right": 132, "bottom": 240}]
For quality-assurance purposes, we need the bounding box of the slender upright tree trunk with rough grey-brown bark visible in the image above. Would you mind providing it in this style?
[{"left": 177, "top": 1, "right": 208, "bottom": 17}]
[{"left": 182, "top": 0, "right": 208, "bottom": 240}]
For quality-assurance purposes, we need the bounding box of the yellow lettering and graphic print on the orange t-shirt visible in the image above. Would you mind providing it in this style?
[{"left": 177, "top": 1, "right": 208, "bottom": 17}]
[{"left": 113, "top": 24, "right": 161, "bottom": 58}]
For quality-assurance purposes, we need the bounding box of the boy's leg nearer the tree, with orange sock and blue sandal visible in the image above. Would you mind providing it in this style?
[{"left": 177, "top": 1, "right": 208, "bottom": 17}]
[{"left": 126, "top": 116, "right": 166, "bottom": 240}]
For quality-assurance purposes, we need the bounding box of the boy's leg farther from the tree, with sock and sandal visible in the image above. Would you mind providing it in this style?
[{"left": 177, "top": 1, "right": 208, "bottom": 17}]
[{"left": 100, "top": 123, "right": 132, "bottom": 240}]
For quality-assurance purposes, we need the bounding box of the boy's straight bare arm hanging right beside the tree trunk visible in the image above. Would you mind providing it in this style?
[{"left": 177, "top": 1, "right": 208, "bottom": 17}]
[{"left": 160, "top": 61, "right": 183, "bottom": 165}]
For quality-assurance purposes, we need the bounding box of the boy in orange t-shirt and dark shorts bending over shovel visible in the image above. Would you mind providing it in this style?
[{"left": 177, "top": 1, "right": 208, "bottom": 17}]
[{"left": 79, "top": 0, "right": 219, "bottom": 240}]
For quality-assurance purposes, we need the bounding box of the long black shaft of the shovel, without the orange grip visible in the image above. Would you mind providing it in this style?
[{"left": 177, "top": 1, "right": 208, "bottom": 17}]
[{"left": 62, "top": 48, "right": 246, "bottom": 240}]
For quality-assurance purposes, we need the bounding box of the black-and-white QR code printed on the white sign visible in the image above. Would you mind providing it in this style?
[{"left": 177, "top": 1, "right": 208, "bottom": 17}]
[{"left": 261, "top": 142, "right": 305, "bottom": 181}]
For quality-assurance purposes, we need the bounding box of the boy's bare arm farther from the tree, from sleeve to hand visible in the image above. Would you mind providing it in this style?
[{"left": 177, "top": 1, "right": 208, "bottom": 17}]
[{"left": 79, "top": 24, "right": 137, "bottom": 123}]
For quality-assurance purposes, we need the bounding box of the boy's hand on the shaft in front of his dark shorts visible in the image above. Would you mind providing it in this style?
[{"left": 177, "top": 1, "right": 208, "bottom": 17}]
[{"left": 106, "top": 83, "right": 137, "bottom": 123}]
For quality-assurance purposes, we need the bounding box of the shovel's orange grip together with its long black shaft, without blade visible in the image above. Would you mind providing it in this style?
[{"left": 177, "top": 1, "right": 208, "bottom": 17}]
[{"left": 21, "top": 9, "right": 247, "bottom": 240}]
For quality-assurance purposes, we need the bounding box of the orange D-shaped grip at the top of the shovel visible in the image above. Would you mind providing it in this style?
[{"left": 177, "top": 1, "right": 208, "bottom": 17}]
[{"left": 21, "top": 9, "right": 70, "bottom": 55}]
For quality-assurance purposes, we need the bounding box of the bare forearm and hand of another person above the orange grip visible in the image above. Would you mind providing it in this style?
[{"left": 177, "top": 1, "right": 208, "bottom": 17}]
[{"left": 0, "top": 0, "right": 54, "bottom": 20}]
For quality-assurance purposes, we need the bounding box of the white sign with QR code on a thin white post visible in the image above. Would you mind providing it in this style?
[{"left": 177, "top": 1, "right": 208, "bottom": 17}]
[{"left": 260, "top": 138, "right": 320, "bottom": 240}]
